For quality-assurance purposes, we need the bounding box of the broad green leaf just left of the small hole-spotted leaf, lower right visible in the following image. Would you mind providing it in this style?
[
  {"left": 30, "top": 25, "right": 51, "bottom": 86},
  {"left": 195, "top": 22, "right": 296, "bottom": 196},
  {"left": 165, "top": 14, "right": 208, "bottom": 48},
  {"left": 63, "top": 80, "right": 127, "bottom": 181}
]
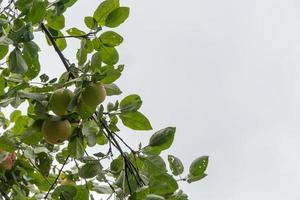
[{"left": 142, "top": 156, "right": 167, "bottom": 176}]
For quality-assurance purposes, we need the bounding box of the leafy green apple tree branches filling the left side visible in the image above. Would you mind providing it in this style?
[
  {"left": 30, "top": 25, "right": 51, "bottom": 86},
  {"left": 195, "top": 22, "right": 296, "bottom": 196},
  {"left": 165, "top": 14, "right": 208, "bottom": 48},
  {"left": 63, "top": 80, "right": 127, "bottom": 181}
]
[{"left": 0, "top": 0, "right": 208, "bottom": 200}]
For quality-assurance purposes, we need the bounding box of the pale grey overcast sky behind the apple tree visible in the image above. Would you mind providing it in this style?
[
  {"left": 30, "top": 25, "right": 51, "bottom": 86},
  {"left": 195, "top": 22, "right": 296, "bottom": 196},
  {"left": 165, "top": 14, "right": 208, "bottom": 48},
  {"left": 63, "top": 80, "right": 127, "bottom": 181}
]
[{"left": 27, "top": 0, "right": 300, "bottom": 200}]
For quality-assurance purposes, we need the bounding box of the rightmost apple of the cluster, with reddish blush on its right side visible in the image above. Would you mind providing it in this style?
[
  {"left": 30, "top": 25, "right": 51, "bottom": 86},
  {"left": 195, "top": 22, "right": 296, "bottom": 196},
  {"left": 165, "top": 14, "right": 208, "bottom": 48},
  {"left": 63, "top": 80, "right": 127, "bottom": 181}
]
[{"left": 82, "top": 82, "right": 106, "bottom": 107}]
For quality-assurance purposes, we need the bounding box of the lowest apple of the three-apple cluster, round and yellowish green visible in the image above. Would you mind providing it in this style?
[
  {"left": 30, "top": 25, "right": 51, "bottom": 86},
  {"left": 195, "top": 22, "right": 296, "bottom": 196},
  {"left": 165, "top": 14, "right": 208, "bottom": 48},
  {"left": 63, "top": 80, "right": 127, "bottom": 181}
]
[{"left": 42, "top": 117, "right": 72, "bottom": 144}]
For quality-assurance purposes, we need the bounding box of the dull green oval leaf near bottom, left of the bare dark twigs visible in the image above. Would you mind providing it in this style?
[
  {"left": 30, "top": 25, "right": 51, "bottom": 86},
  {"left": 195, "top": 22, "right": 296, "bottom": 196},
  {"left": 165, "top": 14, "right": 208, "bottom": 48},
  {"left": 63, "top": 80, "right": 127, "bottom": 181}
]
[{"left": 78, "top": 161, "right": 102, "bottom": 178}]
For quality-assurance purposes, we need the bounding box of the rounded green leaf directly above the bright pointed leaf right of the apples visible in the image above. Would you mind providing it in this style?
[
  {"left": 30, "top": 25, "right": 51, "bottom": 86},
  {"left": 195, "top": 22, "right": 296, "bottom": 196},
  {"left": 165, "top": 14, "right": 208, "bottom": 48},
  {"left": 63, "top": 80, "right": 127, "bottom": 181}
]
[{"left": 120, "top": 94, "right": 143, "bottom": 113}]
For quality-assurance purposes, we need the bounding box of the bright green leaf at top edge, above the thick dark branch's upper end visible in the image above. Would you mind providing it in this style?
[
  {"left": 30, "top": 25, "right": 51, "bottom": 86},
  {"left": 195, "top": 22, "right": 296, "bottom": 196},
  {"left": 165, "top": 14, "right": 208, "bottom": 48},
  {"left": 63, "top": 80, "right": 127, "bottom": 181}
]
[{"left": 27, "top": 0, "right": 47, "bottom": 24}]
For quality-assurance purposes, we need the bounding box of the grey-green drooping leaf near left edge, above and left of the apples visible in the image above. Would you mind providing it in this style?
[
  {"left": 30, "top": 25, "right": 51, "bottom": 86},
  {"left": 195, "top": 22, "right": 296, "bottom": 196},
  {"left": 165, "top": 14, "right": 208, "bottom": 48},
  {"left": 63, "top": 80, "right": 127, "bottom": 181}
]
[{"left": 8, "top": 48, "right": 28, "bottom": 74}]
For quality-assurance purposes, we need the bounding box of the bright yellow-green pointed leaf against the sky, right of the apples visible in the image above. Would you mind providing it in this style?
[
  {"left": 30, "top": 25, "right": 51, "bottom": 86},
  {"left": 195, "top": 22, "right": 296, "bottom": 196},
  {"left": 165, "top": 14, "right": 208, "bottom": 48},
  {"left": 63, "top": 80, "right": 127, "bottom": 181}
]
[{"left": 119, "top": 111, "right": 152, "bottom": 130}]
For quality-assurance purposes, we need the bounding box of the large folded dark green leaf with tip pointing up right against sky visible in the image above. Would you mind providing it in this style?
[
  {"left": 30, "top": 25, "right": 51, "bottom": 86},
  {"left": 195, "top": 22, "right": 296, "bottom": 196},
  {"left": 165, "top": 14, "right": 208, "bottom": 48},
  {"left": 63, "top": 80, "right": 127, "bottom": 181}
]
[{"left": 144, "top": 127, "right": 176, "bottom": 155}]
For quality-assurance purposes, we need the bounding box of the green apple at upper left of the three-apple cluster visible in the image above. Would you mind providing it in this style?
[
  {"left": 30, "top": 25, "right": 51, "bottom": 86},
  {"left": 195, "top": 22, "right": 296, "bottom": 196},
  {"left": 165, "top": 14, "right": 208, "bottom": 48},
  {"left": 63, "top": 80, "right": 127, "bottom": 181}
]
[{"left": 49, "top": 88, "right": 74, "bottom": 116}]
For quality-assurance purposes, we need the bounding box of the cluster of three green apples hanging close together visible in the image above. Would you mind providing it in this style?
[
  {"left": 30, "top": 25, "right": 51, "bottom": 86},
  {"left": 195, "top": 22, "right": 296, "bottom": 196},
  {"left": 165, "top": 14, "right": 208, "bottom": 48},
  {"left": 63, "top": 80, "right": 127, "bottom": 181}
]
[{"left": 42, "top": 82, "right": 106, "bottom": 144}]
